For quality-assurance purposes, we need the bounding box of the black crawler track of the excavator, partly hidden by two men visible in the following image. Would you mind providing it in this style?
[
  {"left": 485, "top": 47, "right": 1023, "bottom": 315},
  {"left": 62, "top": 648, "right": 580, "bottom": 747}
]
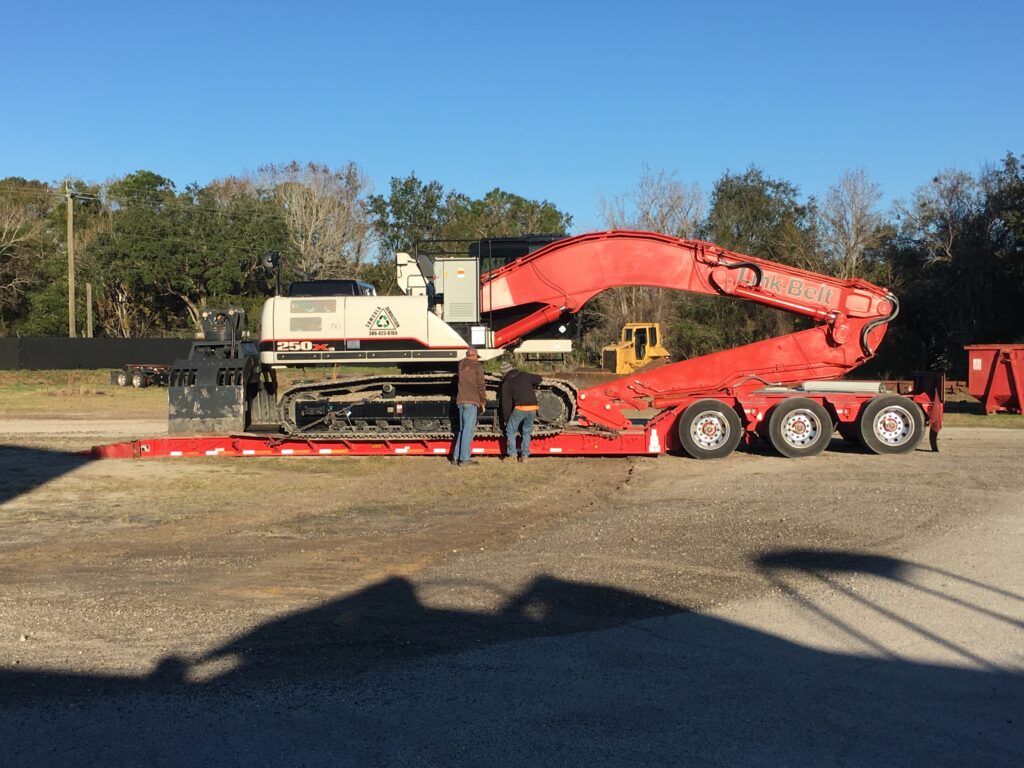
[{"left": 279, "top": 373, "right": 577, "bottom": 440}]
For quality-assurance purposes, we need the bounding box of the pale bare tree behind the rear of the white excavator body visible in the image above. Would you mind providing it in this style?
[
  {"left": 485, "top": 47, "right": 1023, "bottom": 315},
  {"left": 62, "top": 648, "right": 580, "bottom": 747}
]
[{"left": 258, "top": 162, "right": 370, "bottom": 279}]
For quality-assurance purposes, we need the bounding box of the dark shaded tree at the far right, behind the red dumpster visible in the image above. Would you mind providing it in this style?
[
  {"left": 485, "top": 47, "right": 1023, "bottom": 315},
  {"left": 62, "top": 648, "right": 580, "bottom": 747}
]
[{"left": 879, "top": 155, "right": 1024, "bottom": 378}]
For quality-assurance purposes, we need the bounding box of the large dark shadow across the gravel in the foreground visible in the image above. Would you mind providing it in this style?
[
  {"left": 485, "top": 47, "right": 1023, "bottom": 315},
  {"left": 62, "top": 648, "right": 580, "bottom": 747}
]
[{"left": 0, "top": 569, "right": 1024, "bottom": 768}]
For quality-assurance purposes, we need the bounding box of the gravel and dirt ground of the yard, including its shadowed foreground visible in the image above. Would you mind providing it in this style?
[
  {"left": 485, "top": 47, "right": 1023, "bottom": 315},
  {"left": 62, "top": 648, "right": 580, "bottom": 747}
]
[{"left": 0, "top": 422, "right": 1024, "bottom": 766}]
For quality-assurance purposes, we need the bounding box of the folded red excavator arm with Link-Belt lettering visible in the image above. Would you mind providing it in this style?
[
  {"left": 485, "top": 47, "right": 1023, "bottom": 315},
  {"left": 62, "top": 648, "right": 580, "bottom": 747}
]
[{"left": 480, "top": 231, "right": 898, "bottom": 429}]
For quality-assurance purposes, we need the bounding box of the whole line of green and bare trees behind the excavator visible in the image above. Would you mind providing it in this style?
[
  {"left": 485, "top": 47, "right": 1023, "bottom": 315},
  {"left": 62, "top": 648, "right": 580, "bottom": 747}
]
[{"left": 0, "top": 154, "right": 1024, "bottom": 378}]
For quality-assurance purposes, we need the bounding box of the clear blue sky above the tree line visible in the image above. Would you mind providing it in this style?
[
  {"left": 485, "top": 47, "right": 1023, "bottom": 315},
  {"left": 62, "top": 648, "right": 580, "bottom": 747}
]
[{"left": 0, "top": 0, "right": 1024, "bottom": 231}]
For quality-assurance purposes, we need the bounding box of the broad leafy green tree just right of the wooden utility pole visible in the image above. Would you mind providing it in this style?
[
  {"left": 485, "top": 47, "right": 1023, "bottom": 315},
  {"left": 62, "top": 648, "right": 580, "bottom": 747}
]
[{"left": 90, "top": 171, "right": 288, "bottom": 336}]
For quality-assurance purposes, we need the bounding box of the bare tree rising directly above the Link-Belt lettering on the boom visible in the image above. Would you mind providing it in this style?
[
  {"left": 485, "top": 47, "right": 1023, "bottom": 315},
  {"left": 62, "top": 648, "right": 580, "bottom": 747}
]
[{"left": 818, "top": 169, "right": 882, "bottom": 278}]
